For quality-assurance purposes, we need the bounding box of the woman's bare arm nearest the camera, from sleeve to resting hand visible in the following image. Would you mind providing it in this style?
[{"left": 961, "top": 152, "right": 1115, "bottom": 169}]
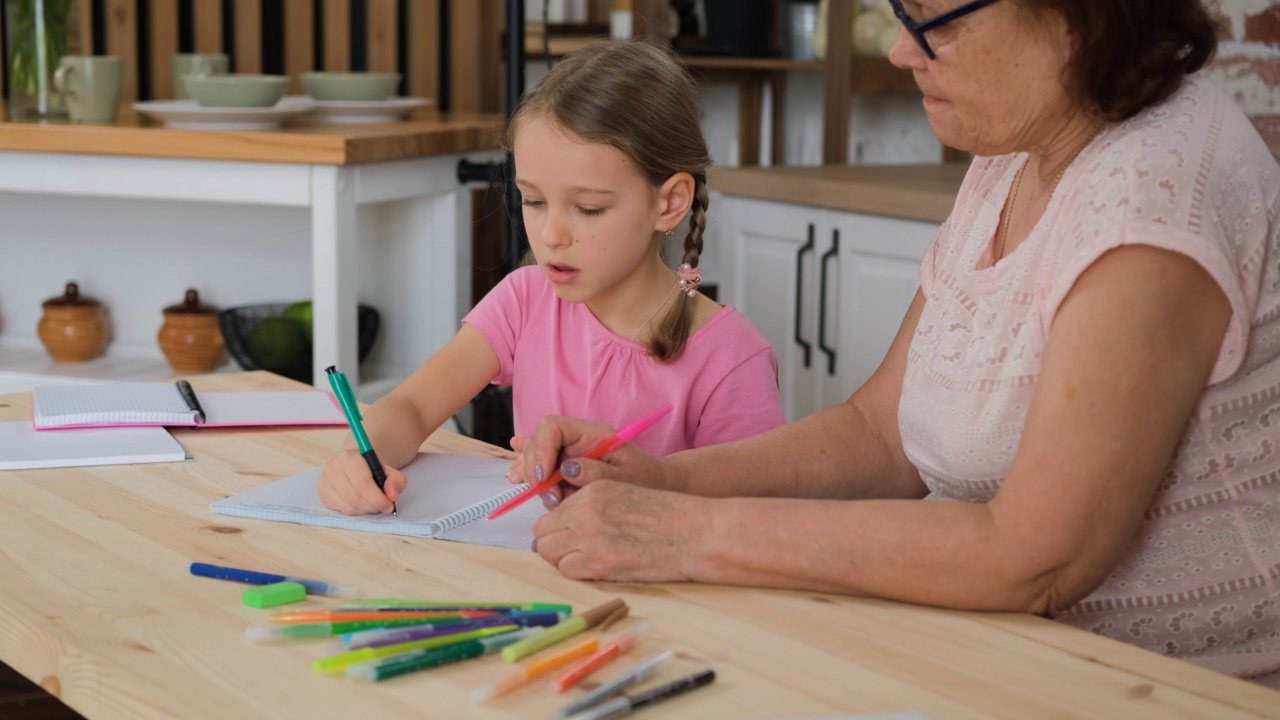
[{"left": 535, "top": 246, "right": 1230, "bottom": 614}]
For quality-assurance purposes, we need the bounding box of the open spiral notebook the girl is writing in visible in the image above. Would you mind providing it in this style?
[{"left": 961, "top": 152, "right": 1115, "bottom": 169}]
[{"left": 210, "top": 452, "right": 547, "bottom": 550}]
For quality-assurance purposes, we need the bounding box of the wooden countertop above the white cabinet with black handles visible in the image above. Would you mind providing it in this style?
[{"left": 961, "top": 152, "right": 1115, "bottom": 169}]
[{"left": 708, "top": 163, "right": 969, "bottom": 223}]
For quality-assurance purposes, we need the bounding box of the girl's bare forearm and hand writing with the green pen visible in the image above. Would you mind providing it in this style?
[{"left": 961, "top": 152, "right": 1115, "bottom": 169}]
[{"left": 319, "top": 323, "right": 500, "bottom": 515}]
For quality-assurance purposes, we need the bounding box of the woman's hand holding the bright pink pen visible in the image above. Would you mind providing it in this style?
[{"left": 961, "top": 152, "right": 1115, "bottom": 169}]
[{"left": 507, "top": 415, "right": 671, "bottom": 509}]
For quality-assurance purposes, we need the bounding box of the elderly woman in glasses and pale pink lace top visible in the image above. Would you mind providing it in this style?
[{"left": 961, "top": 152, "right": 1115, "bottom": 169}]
[{"left": 513, "top": 0, "right": 1280, "bottom": 687}]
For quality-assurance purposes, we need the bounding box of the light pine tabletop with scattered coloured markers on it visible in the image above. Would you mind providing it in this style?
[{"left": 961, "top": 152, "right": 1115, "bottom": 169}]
[{"left": 0, "top": 373, "right": 1280, "bottom": 720}]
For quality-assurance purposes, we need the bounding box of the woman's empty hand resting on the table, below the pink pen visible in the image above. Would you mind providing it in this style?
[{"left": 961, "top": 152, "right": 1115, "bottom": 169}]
[{"left": 534, "top": 479, "right": 714, "bottom": 583}]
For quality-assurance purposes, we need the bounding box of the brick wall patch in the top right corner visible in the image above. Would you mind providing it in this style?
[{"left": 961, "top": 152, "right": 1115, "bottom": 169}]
[{"left": 1210, "top": 0, "right": 1280, "bottom": 158}]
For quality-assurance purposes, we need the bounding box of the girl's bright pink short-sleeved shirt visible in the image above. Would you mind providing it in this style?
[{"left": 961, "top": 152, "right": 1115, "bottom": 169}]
[{"left": 463, "top": 266, "right": 786, "bottom": 455}]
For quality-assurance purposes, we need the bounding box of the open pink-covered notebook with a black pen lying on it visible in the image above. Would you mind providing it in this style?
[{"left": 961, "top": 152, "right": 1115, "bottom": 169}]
[{"left": 33, "top": 380, "right": 347, "bottom": 430}]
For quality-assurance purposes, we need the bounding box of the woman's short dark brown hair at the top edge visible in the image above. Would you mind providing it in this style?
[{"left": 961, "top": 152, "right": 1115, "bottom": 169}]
[{"left": 1019, "top": 0, "right": 1217, "bottom": 120}]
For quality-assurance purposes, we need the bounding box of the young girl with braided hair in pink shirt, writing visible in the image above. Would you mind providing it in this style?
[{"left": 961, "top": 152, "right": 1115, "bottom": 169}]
[{"left": 319, "top": 42, "right": 785, "bottom": 515}]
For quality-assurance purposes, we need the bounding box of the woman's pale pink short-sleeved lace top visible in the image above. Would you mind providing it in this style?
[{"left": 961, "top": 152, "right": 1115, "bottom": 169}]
[{"left": 899, "top": 78, "right": 1280, "bottom": 687}]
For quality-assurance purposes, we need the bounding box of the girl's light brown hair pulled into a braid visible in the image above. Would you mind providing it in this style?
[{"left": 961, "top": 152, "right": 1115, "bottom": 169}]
[{"left": 506, "top": 41, "right": 712, "bottom": 361}]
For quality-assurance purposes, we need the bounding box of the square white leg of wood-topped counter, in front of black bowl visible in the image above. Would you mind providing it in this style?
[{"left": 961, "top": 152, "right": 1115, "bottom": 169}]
[{"left": 304, "top": 165, "right": 360, "bottom": 388}]
